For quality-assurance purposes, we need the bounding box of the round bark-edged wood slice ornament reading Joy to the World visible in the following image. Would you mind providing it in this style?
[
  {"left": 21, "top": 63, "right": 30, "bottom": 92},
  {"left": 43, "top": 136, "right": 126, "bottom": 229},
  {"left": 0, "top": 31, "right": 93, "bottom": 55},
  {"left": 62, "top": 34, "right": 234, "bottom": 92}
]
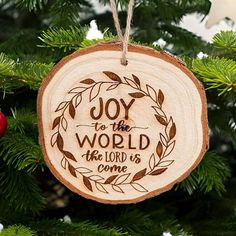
[{"left": 38, "top": 43, "right": 208, "bottom": 204}]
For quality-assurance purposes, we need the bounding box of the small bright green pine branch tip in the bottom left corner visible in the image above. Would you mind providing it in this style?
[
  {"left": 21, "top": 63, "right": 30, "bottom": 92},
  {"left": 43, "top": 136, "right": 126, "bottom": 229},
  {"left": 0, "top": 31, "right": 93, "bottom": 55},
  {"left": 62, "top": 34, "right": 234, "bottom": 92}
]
[{"left": 1, "top": 225, "right": 36, "bottom": 236}]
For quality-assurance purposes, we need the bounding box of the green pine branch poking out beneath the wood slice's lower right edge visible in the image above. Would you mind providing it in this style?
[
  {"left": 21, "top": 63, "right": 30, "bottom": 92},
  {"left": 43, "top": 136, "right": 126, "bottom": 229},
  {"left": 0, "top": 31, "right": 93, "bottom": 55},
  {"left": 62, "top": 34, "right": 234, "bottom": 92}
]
[{"left": 176, "top": 152, "right": 231, "bottom": 195}]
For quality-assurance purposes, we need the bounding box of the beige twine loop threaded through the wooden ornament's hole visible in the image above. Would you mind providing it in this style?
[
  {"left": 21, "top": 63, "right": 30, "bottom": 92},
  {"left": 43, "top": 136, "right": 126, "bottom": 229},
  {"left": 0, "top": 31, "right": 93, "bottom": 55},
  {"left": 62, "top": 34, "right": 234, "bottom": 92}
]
[{"left": 110, "top": 0, "right": 134, "bottom": 65}]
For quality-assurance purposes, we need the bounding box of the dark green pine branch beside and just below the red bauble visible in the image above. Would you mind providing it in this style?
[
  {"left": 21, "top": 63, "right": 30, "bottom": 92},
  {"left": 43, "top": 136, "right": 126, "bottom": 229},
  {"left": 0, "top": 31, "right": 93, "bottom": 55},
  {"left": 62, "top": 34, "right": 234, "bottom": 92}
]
[{"left": 0, "top": 109, "right": 44, "bottom": 172}]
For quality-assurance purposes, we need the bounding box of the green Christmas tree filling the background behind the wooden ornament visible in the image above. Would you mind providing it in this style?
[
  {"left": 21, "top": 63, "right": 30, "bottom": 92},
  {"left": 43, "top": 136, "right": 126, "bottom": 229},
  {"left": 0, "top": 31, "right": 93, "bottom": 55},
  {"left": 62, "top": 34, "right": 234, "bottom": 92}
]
[{"left": 0, "top": 0, "right": 236, "bottom": 236}]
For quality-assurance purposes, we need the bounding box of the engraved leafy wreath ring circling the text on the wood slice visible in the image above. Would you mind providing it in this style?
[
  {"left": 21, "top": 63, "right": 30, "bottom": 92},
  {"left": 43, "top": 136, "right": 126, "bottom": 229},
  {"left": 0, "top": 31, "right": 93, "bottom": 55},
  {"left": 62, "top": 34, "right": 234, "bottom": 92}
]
[{"left": 51, "top": 71, "right": 176, "bottom": 194}]
